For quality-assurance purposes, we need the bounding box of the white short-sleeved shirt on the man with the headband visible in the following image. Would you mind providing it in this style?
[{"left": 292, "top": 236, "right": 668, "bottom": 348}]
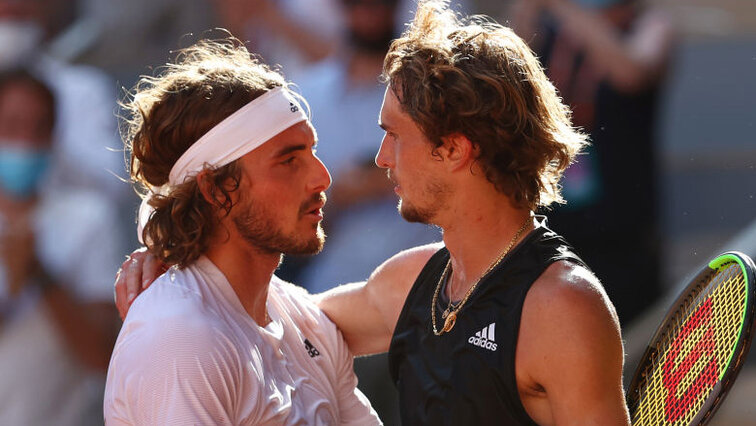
[{"left": 104, "top": 257, "right": 381, "bottom": 425}]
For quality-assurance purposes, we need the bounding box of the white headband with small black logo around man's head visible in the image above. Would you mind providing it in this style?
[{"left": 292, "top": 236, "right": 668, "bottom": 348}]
[{"left": 137, "top": 87, "right": 307, "bottom": 243}]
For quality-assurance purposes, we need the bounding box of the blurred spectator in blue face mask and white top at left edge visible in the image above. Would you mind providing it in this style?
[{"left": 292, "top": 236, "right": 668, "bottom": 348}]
[{"left": 0, "top": 71, "right": 121, "bottom": 425}]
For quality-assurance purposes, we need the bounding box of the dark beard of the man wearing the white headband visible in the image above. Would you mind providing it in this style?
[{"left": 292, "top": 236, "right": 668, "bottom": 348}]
[{"left": 233, "top": 194, "right": 325, "bottom": 255}]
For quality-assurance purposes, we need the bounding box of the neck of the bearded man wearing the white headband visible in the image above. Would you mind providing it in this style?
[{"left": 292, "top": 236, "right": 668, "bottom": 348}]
[{"left": 205, "top": 238, "right": 281, "bottom": 326}]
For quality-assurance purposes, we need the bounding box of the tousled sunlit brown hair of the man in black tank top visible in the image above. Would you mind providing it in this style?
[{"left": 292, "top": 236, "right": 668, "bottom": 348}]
[{"left": 383, "top": 1, "right": 586, "bottom": 209}]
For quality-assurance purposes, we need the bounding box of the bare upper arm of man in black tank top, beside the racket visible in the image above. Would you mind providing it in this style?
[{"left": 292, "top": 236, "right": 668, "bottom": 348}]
[{"left": 516, "top": 262, "right": 629, "bottom": 426}]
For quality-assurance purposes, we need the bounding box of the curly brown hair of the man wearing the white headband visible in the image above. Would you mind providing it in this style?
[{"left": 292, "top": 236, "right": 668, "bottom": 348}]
[{"left": 120, "top": 37, "right": 286, "bottom": 267}]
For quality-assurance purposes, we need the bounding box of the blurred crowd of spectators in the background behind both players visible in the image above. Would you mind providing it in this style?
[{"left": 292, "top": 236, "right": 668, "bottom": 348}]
[{"left": 0, "top": 0, "right": 684, "bottom": 425}]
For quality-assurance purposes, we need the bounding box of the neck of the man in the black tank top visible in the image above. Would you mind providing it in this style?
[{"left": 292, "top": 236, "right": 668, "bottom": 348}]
[{"left": 439, "top": 186, "right": 533, "bottom": 299}]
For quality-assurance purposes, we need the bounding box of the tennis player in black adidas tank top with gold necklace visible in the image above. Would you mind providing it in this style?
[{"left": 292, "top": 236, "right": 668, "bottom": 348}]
[{"left": 116, "top": 0, "right": 642, "bottom": 426}]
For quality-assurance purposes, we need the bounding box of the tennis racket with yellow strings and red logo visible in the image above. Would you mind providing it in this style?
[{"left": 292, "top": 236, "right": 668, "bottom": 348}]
[{"left": 627, "top": 252, "right": 756, "bottom": 426}]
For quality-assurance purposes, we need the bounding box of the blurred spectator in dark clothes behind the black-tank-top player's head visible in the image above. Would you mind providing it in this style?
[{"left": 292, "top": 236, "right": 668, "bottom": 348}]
[{"left": 514, "top": 0, "right": 672, "bottom": 323}]
